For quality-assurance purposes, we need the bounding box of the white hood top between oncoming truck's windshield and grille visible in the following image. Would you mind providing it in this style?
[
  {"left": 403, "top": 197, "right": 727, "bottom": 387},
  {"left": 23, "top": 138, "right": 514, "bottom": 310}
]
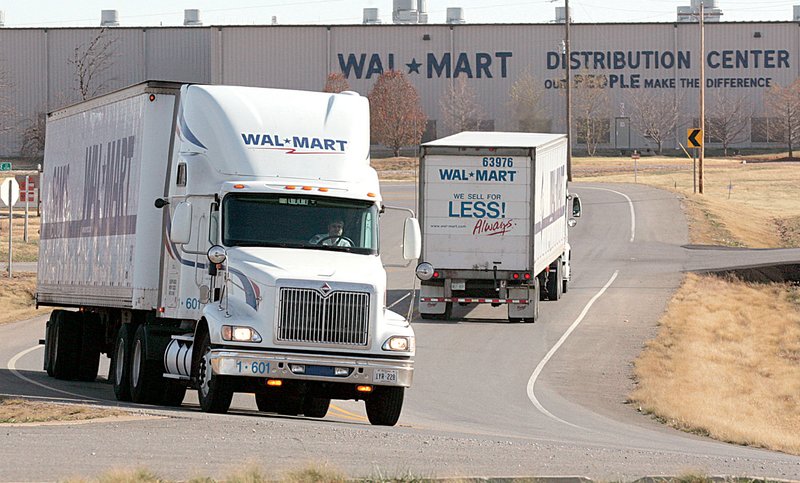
[{"left": 228, "top": 247, "right": 386, "bottom": 290}]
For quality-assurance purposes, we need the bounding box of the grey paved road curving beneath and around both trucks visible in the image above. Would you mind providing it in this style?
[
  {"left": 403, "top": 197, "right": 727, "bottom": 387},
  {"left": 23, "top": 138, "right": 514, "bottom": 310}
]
[{"left": 0, "top": 183, "right": 800, "bottom": 481}]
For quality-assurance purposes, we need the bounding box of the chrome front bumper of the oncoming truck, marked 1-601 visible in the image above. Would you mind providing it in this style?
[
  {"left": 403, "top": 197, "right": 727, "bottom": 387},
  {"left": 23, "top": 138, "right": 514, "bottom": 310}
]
[{"left": 209, "top": 349, "right": 414, "bottom": 387}]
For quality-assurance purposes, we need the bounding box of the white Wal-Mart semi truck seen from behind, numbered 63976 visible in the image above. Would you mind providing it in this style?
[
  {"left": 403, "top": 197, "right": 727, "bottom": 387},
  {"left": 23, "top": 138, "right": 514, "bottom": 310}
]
[{"left": 416, "top": 132, "right": 581, "bottom": 322}]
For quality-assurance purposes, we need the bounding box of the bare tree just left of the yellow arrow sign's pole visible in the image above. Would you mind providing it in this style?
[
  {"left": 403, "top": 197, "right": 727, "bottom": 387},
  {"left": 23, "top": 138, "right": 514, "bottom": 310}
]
[{"left": 631, "top": 89, "right": 680, "bottom": 154}]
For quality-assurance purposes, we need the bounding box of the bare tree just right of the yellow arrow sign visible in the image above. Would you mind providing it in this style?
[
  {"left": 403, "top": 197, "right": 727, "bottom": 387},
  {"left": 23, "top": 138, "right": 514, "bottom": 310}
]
[{"left": 705, "top": 90, "right": 753, "bottom": 156}]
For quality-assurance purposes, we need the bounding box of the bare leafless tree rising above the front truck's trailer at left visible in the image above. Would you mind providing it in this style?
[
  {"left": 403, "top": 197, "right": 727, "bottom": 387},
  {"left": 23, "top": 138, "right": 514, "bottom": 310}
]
[{"left": 67, "top": 27, "right": 116, "bottom": 101}]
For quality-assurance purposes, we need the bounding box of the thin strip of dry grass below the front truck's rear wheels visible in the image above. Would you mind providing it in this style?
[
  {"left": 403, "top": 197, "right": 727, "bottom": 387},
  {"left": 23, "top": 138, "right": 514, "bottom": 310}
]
[{"left": 0, "top": 397, "right": 127, "bottom": 424}]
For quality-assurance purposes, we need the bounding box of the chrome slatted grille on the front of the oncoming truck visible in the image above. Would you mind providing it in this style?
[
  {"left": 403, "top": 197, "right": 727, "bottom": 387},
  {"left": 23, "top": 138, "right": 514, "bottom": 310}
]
[{"left": 278, "top": 288, "right": 369, "bottom": 346}]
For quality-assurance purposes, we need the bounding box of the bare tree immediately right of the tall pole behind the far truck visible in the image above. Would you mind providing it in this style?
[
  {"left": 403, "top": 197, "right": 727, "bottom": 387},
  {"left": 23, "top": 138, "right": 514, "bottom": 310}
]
[{"left": 572, "top": 76, "right": 611, "bottom": 156}]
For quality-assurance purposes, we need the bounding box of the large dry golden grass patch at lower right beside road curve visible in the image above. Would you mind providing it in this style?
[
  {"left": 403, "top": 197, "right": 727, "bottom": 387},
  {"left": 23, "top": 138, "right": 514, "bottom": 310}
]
[{"left": 631, "top": 275, "right": 800, "bottom": 454}]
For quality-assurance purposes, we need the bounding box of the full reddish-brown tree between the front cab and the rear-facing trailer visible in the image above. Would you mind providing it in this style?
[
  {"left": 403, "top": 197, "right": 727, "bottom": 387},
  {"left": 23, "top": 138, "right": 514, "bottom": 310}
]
[{"left": 367, "top": 70, "right": 428, "bottom": 156}]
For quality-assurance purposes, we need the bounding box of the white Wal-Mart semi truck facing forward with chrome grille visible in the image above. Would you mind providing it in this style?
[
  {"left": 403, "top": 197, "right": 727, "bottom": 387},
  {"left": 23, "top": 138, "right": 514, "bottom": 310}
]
[{"left": 36, "top": 81, "right": 420, "bottom": 425}]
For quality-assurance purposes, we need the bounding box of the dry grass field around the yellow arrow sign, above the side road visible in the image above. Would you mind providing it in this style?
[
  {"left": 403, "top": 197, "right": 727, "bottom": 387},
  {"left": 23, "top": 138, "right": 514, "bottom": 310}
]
[{"left": 573, "top": 158, "right": 800, "bottom": 248}]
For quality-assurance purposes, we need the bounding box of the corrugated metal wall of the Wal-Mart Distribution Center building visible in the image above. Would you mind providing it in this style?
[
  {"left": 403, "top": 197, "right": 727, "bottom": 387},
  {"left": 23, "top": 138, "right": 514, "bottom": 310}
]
[{"left": 0, "top": 22, "right": 800, "bottom": 156}]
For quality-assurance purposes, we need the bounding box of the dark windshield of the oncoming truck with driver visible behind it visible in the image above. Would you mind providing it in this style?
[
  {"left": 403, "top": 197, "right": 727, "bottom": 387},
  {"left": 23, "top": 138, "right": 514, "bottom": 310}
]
[{"left": 222, "top": 193, "right": 378, "bottom": 255}]
